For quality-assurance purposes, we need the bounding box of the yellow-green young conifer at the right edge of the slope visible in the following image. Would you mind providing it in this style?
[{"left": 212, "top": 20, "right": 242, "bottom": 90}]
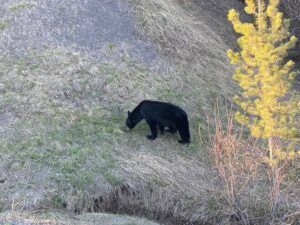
[{"left": 227, "top": 0, "right": 299, "bottom": 163}]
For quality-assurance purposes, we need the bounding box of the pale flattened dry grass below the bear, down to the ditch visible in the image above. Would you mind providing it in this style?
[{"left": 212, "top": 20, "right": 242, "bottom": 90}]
[{"left": 90, "top": 154, "right": 218, "bottom": 224}]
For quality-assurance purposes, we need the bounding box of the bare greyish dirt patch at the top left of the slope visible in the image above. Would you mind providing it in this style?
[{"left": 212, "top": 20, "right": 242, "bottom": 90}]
[{"left": 0, "top": 0, "right": 158, "bottom": 63}]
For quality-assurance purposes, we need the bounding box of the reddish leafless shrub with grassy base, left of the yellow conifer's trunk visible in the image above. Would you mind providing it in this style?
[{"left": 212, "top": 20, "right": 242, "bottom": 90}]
[{"left": 208, "top": 106, "right": 268, "bottom": 225}]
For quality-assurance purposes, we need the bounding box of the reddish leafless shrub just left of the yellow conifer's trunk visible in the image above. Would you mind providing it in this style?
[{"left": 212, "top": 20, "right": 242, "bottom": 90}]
[{"left": 210, "top": 108, "right": 262, "bottom": 224}]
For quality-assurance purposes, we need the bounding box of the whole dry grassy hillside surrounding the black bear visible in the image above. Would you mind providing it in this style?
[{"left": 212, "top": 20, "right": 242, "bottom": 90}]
[{"left": 0, "top": 0, "right": 298, "bottom": 224}]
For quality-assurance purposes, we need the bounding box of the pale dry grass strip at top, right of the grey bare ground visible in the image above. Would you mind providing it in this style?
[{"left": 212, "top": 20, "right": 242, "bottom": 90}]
[{"left": 132, "top": 0, "right": 229, "bottom": 64}]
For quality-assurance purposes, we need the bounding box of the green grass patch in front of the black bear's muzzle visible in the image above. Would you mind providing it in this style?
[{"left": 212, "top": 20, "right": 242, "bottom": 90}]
[{"left": 6, "top": 106, "right": 124, "bottom": 189}]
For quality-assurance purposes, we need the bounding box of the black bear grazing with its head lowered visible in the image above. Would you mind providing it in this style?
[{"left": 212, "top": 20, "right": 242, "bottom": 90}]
[{"left": 126, "top": 100, "right": 191, "bottom": 144}]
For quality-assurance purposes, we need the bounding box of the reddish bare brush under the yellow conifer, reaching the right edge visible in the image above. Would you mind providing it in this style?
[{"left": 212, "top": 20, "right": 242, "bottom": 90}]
[{"left": 208, "top": 106, "right": 299, "bottom": 224}]
